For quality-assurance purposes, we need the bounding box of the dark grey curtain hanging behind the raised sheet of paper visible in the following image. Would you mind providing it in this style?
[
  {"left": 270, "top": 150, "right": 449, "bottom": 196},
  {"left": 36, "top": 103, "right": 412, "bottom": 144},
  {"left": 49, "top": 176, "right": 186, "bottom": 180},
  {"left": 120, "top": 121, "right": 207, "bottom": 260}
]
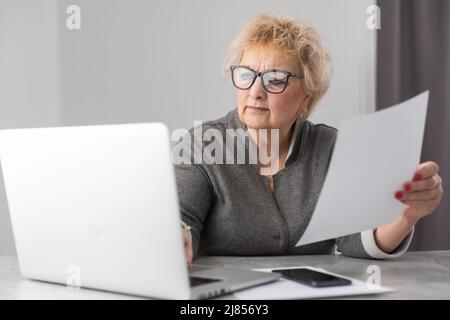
[{"left": 376, "top": 0, "right": 450, "bottom": 250}]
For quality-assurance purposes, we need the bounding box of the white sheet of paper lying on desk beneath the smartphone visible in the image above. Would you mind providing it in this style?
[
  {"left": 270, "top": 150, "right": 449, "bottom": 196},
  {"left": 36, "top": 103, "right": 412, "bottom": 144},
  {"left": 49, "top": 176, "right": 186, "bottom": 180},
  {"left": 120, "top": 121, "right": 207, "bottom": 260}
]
[{"left": 234, "top": 267, "right": 394, "bottom": 300}]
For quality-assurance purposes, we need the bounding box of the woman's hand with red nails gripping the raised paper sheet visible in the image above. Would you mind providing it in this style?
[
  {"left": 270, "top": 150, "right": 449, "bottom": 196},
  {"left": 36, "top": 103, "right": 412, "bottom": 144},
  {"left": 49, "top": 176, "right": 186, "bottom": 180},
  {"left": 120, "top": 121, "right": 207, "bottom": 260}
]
[{"left": 395, "top": 161, "right": 444, "bottom": 221}]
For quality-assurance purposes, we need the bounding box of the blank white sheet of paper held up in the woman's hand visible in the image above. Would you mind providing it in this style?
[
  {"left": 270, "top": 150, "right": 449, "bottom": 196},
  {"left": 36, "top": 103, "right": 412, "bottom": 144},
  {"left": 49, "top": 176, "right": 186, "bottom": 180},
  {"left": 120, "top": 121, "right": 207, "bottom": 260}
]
[{"left": 296, "top": 91, "right": 429, "bottom": 246}]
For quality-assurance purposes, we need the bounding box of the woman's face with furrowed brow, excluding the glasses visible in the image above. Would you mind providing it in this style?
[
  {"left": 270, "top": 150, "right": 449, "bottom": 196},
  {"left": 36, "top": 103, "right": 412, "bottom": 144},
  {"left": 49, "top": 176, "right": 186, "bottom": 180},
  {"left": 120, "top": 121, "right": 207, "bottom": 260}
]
[{"left": 236, "top": 46, "right": 304, "bottom": 130}]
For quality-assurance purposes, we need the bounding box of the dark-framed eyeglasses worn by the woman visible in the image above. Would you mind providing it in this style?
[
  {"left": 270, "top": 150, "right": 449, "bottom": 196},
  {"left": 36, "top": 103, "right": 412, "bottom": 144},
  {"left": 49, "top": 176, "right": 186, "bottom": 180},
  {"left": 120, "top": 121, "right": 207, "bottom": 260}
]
[{"left": 230, "top": 66, "right": 303, "bottom": 93}]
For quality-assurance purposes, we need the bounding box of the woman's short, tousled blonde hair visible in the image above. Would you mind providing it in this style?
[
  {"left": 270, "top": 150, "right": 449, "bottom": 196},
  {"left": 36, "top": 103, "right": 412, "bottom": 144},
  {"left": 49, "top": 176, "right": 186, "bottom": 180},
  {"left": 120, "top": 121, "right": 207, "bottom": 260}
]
[{"left": 224, "top": 15, "right": 331, "bottom": 119}]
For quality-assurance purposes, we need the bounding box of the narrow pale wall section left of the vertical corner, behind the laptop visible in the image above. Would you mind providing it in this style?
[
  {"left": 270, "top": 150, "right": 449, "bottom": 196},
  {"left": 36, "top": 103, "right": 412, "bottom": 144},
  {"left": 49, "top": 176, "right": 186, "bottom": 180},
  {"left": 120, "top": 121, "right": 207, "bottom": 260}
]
[{"left": 0, "top": 0, "right": 61, "bottom": 255}]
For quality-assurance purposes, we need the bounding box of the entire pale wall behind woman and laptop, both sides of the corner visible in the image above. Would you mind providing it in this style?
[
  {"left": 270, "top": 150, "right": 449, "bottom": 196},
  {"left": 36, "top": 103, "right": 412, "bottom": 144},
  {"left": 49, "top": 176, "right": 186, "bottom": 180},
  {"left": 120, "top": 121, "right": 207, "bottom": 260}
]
[{"left": 0, "top": 0, "right": 375, "bottom": 255}]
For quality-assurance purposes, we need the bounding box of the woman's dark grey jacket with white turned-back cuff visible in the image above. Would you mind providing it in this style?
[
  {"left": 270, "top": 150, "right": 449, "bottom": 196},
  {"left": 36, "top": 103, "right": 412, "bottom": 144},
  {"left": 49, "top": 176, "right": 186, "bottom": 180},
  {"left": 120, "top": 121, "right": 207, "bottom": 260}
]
[{"left": 174, "top": 109, "right": 412, "bottom": 258}]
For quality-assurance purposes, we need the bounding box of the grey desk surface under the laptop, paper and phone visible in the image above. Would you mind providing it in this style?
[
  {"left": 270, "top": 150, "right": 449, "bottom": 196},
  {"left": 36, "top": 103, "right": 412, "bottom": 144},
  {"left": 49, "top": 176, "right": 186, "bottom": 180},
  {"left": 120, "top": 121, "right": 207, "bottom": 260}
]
[{"left": 0, "top": 251, "right": 450, "bottom": 299}]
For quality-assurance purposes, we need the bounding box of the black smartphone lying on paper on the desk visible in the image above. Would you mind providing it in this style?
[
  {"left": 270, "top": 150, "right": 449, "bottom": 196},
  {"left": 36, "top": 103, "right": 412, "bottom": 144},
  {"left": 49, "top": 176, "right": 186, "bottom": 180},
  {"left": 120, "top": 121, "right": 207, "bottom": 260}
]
[{"left": 272, "top": 268, "right": 352, "bottom": 288}]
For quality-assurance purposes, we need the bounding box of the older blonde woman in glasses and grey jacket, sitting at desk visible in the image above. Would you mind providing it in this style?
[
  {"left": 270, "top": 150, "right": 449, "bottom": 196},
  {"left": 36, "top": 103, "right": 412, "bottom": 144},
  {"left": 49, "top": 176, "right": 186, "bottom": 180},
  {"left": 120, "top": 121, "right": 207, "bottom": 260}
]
[{"left": 176, "top": 15, "right": 443, "bottom": 265}]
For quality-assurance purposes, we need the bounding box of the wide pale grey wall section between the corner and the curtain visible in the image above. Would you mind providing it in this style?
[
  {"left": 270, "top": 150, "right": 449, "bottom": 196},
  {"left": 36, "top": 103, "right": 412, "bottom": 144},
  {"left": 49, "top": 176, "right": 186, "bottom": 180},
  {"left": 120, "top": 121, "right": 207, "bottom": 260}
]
[{"left": 59, "top": 0, "right": 375, "bottom": 129}]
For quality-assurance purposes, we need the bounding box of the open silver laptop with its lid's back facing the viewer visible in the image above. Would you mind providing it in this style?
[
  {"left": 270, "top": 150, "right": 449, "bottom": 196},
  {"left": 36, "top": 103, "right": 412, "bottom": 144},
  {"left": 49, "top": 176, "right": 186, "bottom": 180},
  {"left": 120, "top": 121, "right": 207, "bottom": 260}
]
[{"left": 0, "top": 123, "right": 279, "bottom": 299}]
